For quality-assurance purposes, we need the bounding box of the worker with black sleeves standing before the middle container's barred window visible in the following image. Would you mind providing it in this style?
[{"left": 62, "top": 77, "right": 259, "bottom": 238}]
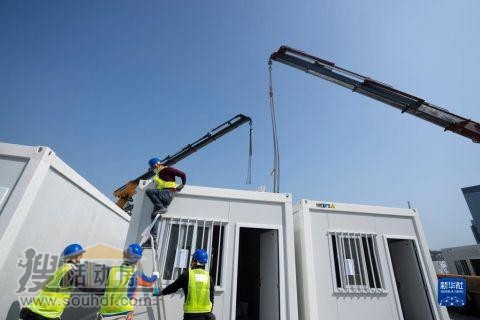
[{"left": 160, "top": 249, "right": 215, "bottom": 320}]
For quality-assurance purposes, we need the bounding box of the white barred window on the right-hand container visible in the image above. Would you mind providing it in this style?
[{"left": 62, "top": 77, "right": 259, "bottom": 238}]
[{"left": 327, "top": 231, "right": 388, "bottom": 294}]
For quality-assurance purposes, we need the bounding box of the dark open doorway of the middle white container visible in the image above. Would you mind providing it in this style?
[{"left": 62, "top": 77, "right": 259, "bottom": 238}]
[{"left": 235, "top": 227, "right": 280, "bottom": 320}]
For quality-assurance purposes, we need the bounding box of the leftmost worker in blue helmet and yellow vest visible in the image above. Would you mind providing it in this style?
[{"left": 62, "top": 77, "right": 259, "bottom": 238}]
[{"left": 20, "top": 243, "right": 85, "bottom": 320}]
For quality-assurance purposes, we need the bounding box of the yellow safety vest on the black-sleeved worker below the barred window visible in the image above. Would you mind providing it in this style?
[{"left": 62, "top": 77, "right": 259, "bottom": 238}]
[{"left": 183, "top": 269, "right": 212, "bottom": 313}]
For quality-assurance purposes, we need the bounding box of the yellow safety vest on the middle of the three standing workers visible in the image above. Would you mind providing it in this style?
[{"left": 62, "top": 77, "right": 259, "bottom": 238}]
[{"left": 100, "top": 265, "right": 135, "bottom": 316}]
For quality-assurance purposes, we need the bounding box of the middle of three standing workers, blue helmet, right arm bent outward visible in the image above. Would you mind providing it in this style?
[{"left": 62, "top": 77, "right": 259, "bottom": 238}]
[{"left": 97, "top": 244, "right": 159, "bottom": 320}]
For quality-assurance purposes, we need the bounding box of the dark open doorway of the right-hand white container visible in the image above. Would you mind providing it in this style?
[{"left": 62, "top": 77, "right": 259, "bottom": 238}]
[{"left": 388, "top": 239, "right": 435, "bottom": 320}]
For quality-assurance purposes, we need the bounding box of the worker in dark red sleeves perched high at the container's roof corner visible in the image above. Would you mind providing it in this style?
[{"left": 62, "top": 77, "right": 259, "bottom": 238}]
[{"left": 145, "top": 158, "right": 187, "bottom": 246}]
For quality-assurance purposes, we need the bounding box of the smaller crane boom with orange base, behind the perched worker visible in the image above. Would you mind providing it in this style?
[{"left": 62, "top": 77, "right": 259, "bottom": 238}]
[{"left": 113, "top": 114, "right": 252, "bottom": 209}]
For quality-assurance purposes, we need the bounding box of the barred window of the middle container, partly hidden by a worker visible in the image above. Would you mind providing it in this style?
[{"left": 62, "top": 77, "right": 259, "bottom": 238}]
[{"left": 157, "top": 217, "right": 227, "bottom": 288}]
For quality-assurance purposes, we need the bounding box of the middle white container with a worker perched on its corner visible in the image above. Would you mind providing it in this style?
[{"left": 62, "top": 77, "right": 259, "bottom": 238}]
[{"left": 127, "top": 182, "right": 298, "bottom": 320}]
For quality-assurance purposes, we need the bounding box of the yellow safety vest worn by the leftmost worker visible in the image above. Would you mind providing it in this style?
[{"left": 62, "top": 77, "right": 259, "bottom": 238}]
[{"left": 27, "top": 263, "right": 74, "bottom": 319}]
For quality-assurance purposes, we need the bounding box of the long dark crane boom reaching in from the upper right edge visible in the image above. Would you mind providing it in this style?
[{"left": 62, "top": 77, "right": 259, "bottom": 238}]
[{"left": 269, "top": 46, "right": 480, "bottom": 143}]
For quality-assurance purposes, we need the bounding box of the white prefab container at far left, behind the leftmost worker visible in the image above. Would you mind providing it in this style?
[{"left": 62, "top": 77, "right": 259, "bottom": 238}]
[{"left": 0, "top": 143, "right": 129, "bottom": 320}]
